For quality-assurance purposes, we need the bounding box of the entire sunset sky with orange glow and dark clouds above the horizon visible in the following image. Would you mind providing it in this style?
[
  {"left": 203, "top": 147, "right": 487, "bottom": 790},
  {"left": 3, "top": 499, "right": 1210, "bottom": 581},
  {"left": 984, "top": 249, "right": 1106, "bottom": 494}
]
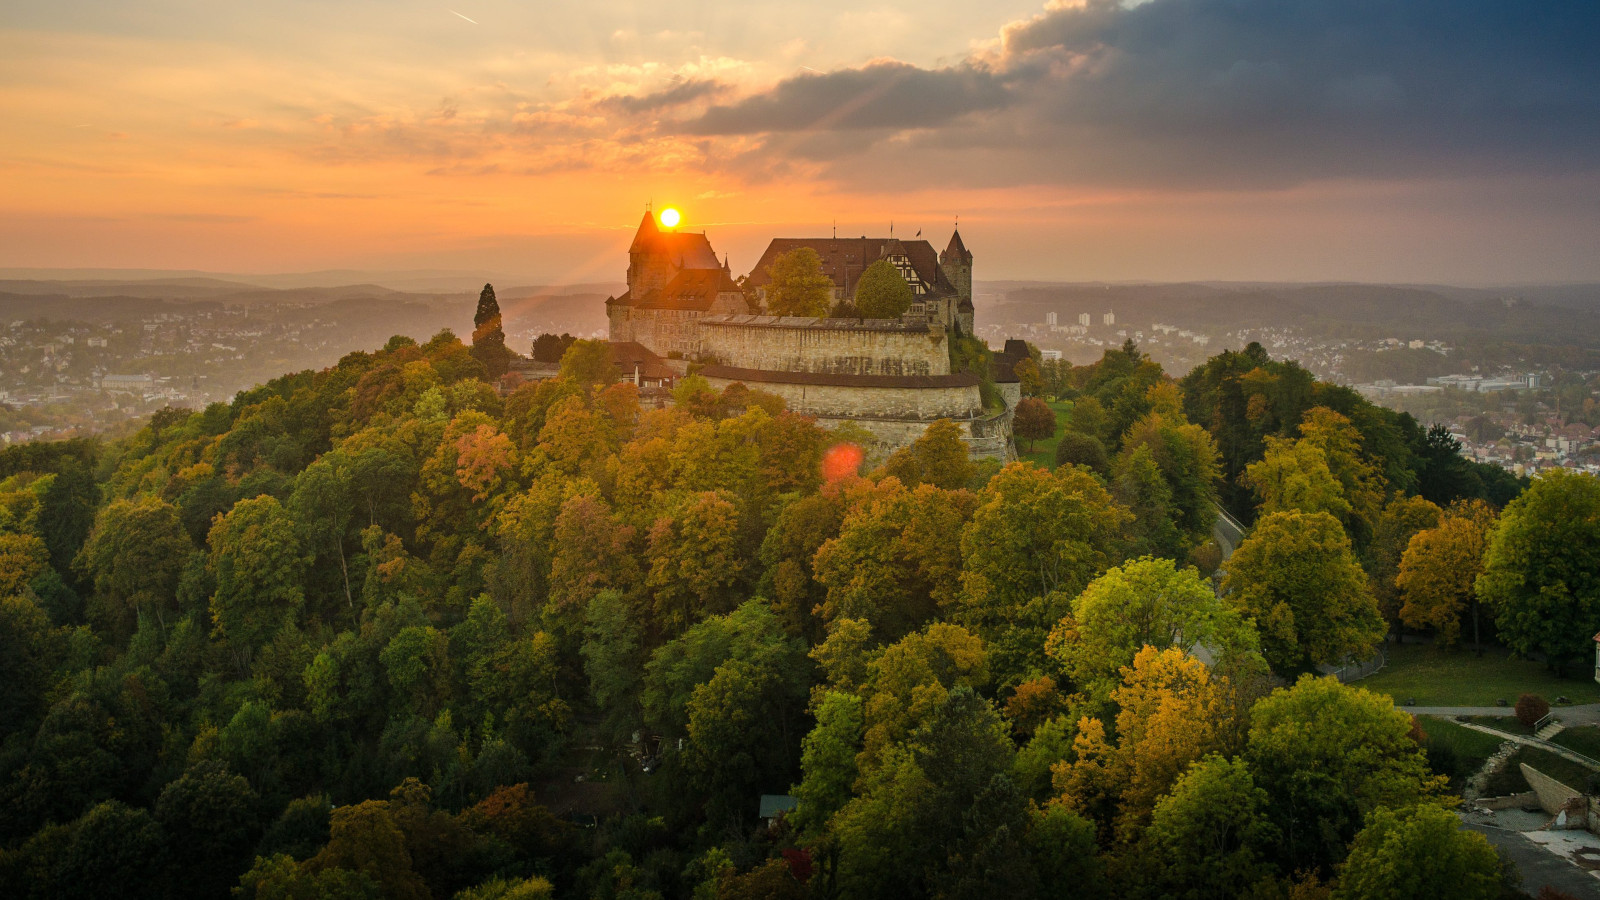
[{"left": 0, "top": 0, "right": 1600, "bottom": 285}]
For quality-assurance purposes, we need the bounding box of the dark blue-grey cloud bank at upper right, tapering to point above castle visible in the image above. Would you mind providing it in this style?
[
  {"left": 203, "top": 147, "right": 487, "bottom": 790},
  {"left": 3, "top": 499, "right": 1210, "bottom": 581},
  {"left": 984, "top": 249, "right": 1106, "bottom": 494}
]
[{"left": 686, "top": 0, "right": 1600, "bottom": 186}]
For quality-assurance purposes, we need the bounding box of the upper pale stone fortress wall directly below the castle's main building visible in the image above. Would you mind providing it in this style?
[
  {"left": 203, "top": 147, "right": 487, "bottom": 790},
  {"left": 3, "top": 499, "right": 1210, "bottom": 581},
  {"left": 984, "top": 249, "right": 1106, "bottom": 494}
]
[{"left": 698, "top": 315, "right": 950, "bottom": 376}]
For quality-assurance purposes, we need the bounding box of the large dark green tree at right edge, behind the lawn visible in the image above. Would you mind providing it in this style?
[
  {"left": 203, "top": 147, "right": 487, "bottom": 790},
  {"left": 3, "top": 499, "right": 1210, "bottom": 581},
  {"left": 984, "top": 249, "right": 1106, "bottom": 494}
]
[{"left": 1477, "top": 469, "right": 1600, "bottom": 671}]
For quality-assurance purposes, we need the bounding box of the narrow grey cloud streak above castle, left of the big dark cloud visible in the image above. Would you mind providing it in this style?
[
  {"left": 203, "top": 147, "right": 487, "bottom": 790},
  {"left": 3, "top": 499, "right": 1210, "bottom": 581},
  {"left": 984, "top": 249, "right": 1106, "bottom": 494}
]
[{"left": 686, "top": 62, "right": 1006, "bottom": 135}]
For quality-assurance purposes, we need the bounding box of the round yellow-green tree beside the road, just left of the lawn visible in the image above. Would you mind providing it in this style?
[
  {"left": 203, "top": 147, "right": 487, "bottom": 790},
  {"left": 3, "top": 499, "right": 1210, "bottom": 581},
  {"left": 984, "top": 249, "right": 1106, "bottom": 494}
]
[{"left": 1222, "top": 512, "right": 1384, "bottom": 674}]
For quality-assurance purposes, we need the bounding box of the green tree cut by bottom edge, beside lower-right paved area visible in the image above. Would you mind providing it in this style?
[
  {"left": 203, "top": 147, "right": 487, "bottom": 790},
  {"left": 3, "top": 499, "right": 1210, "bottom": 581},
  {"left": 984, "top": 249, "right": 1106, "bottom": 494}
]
[{"left": 1333, "top": 804, "right": 1506, "bottom": 900}]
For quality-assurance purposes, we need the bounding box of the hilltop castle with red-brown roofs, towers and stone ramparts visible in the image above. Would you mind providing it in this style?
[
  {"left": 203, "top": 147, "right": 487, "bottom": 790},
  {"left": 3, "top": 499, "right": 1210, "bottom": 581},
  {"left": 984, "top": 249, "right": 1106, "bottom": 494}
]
[{"left": 606, "top": 213, "right": 1019, "bottom": 460}]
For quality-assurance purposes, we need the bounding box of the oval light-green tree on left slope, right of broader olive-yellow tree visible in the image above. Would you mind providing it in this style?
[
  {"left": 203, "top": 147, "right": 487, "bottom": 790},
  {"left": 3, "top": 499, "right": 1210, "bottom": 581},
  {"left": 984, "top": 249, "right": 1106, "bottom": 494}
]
[{"left": 208, "top": 495, "right": 310, "bottom": 668}]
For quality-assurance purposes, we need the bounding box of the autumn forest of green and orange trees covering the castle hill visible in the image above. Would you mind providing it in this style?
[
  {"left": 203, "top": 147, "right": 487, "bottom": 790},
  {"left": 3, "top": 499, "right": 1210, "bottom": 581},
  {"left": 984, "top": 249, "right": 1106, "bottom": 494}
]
[{"left": 0, "top": 323, "right": 1600, "bottom": 900}]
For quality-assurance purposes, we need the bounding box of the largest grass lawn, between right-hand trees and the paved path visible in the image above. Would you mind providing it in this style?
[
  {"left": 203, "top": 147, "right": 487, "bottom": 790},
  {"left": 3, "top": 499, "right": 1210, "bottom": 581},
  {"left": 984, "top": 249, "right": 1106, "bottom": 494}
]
[{"left": 1355, "top": 644, "right": 1600, "bottom": 706}]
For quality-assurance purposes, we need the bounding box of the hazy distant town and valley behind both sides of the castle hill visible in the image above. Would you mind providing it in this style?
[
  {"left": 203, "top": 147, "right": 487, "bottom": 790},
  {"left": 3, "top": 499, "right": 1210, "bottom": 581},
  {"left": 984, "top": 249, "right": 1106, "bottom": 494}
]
[{"left": 0, "top": 277, "right": 1600, "bottom": 474}]
